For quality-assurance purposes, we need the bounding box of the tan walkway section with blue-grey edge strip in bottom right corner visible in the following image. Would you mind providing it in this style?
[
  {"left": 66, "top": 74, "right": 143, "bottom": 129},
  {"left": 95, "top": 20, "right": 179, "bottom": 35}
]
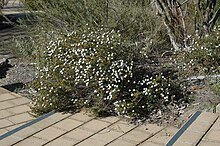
[{"left": 167, "top": 111, "right": 220, "bottom": 146}]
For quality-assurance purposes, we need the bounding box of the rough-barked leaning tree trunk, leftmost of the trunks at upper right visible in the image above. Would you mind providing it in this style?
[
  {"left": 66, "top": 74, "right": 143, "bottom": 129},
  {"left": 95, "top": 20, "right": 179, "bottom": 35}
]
[{"left": 155, "top": 0, "right": 186, "bottom": 50}]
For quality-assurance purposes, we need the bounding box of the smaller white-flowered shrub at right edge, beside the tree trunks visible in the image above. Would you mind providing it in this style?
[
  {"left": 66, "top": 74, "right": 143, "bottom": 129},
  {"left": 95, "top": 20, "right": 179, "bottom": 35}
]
[{"left": 174, "top": 26, "right": 220, "bottom": 76}]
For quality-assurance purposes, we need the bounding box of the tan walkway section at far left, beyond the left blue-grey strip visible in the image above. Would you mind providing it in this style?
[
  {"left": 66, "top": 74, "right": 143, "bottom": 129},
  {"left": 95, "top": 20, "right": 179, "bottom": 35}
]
[{"left": 0, "top": 88, "right": 34, "bottom": 137}]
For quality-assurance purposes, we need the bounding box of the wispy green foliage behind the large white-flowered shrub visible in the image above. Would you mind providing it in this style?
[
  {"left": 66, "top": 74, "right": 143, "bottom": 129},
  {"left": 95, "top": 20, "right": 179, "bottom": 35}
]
[{"left": 11, "top": 0, "right": 170, "bottom": 62}]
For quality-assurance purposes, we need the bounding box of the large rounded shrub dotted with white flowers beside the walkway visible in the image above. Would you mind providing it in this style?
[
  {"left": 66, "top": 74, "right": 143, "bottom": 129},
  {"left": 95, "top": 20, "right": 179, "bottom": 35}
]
[{"left": 32, "top": 28, "right": 186, "bottom": 118}]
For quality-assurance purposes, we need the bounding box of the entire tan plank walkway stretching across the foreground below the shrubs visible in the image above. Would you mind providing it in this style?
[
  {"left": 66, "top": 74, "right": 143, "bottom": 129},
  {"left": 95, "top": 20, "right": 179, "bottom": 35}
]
[{"left": 0, "top": 88, "right": 220, "bottom": 146}]
